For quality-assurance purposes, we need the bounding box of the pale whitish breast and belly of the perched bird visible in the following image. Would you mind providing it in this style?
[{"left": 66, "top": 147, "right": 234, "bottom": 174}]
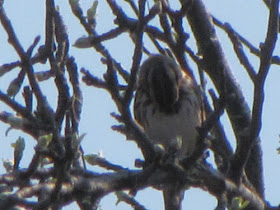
[{"left": 144, "top": 95, "right": 201, "bottom": 154}]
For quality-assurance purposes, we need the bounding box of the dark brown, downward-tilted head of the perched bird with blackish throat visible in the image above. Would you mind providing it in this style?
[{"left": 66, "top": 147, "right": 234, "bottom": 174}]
[{"left": 138, "top": 55, "right": 182, "bottom": 112}]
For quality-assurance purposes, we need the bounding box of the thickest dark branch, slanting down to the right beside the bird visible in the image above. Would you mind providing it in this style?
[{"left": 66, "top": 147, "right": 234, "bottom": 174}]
[{"left": 187, "top": 0, "right": 264, "bottom": 196}]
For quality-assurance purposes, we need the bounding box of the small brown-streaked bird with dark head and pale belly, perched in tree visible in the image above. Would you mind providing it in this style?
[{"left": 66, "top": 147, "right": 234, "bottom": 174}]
[{"left": 133, "top": 54, "right": 203, "bottom": 209}]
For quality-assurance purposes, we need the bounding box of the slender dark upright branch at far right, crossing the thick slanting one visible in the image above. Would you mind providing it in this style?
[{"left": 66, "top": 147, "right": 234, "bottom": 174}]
[{"left": 230, "top": 0, "right": 279, "bottom": 189}]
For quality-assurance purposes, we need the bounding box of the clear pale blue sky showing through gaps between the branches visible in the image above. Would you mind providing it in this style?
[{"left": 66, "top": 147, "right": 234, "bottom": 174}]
[{"left": 0, "top": 0, "right": 280, "bottom": 210}]
